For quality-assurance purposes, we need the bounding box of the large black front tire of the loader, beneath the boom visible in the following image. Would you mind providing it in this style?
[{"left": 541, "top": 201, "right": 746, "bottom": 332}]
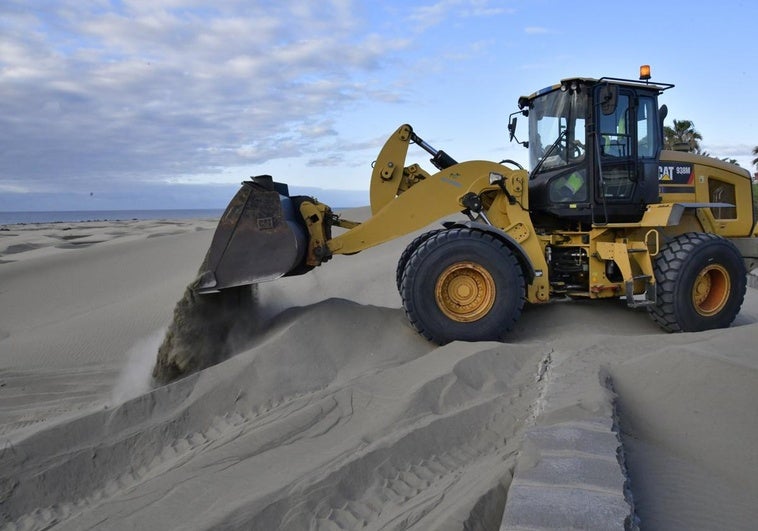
[{"left": 400, "top": 227, "right": 526, "bottom": 345}]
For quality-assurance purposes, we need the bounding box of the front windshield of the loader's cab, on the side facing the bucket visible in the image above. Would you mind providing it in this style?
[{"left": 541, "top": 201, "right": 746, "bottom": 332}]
[{"left": 529, "top": 90, "right": 588, "bottom": 173}]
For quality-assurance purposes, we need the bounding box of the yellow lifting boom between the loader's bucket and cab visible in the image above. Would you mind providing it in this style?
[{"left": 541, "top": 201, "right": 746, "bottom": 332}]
[{"left": 300, "top": 124, "right": 548, "bottom": 303}]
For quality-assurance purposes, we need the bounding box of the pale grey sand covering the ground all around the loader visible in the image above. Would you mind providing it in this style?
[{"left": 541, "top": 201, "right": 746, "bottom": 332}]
[{"left": 0, "top": 211, "right": 758, "bottom": 530}]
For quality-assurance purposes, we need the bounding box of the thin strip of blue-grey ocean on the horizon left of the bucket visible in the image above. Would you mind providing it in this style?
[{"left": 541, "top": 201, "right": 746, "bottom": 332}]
[{"left": 0, "top": 208, "right": 224, "bottom": 225}]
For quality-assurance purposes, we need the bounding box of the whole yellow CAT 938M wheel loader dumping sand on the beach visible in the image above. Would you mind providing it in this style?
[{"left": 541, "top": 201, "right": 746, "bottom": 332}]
[{"left": 192, "top": 67, "right": 758, "bottom": 344}]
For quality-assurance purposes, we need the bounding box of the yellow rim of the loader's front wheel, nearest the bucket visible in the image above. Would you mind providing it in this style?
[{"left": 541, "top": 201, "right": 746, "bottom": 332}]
[{"left": 434, "top": 261, "right": 495, "bottom": 323}]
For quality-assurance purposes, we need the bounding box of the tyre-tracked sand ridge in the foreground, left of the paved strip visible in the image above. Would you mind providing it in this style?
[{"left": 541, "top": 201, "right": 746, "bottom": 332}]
[{"left": 2, "top": 300, "right": 540, "bottom": 529}]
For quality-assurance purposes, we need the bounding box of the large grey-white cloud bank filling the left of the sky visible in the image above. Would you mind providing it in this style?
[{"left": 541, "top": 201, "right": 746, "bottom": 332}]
[{"left": 0, "top": 0, "right": 408, "bottom": 197}]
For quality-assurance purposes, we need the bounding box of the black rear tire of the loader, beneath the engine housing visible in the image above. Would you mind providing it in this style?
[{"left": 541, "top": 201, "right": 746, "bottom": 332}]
[{"left": 648, "top": 232, "right": 747, "bottom": 332}]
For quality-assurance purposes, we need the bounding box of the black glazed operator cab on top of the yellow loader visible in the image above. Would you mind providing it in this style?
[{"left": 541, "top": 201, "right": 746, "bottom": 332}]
[{"left": 508, "top": 68, "right": 673, "bottom": 226}]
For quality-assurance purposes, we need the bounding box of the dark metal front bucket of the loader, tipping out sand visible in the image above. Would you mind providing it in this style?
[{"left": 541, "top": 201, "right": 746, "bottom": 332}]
[{"left": 192, "top": 175, "right": 308, "bottom": 293}]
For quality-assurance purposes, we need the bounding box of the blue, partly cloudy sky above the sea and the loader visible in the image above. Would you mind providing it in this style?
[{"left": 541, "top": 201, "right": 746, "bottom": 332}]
[{"left": 0, "top": 0, "right": 758, "bottom": 211}]
